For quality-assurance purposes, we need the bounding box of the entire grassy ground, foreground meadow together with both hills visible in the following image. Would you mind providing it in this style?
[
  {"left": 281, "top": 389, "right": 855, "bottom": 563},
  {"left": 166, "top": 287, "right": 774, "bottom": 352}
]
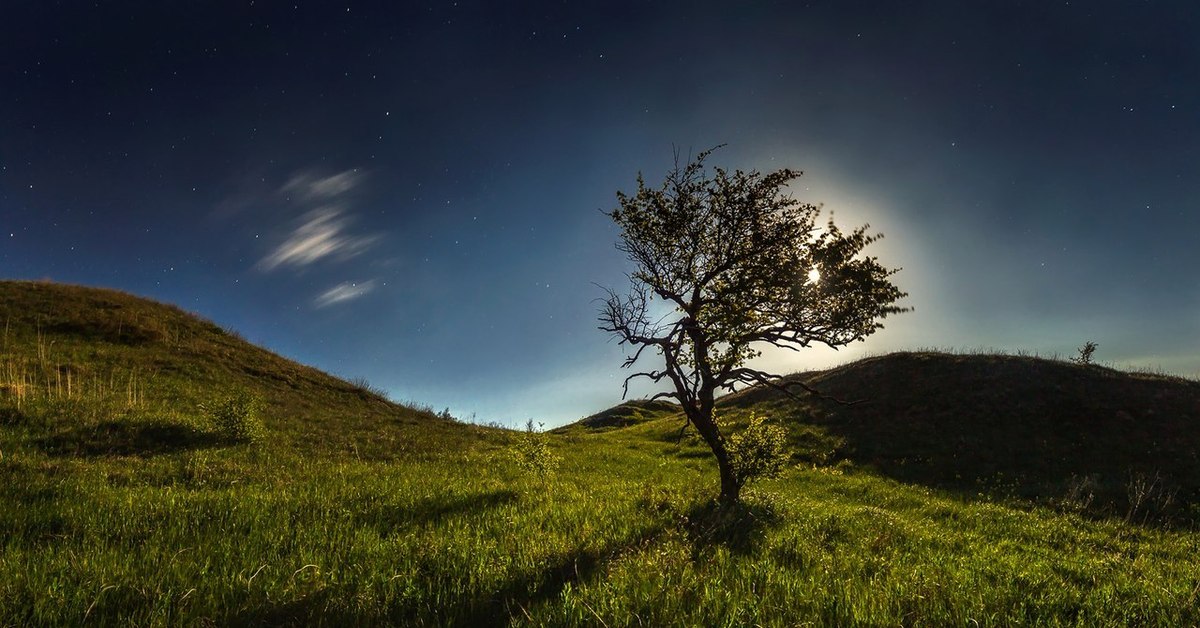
[{"left": 0, "top": 282, "right": 1200, "bottom": 627}]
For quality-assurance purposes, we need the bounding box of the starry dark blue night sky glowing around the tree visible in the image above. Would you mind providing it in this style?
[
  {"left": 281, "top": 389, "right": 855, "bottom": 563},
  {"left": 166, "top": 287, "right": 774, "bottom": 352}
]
[{"left": 0, "top": 0, "right": 1200, "bottom": 426}]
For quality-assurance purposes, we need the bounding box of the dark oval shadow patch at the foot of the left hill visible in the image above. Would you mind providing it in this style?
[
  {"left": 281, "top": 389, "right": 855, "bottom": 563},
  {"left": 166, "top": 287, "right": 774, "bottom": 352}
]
[{"left": 36, "top": 420, "right": 227, "bottom": 457}]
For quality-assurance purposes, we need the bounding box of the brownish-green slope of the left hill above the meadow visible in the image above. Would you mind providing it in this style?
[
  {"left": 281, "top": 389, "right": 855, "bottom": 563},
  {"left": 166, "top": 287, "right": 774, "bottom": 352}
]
[{"left": 0, "top": 281, "right": 484, "bottom": 459}]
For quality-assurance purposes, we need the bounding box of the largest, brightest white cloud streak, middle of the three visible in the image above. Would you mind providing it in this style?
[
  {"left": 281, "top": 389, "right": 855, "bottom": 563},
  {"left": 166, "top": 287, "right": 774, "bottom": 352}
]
[{"left": 258, "top": 207, "right": 379, "bottom": 270}]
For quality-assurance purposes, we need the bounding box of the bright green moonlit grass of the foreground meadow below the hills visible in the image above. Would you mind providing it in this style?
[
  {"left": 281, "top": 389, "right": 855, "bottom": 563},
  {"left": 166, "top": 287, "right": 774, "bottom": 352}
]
[{"left": 0, "top": 429, "right": 1200, "bottom": 626}]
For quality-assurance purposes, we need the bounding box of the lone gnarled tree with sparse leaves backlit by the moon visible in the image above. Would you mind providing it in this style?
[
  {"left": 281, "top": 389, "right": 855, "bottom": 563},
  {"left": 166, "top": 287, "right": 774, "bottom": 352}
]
[{"left": 600, "top": 146, "right": 907, "bottom": 503}]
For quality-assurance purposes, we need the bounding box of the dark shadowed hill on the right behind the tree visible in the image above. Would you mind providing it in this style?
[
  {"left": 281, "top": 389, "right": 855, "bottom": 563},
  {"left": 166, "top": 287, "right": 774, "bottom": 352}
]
[{"left": 720, "top": 352, "right": 1200, "bottom": 525}]
